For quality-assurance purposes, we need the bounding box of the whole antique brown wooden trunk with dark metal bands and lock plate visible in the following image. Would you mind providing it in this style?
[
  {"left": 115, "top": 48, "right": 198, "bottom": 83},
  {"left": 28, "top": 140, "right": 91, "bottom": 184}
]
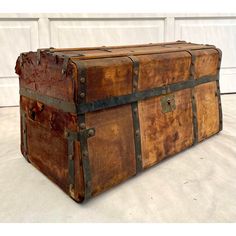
[{"left": 16, "top": 41, "right": 222, "bottom": 202}]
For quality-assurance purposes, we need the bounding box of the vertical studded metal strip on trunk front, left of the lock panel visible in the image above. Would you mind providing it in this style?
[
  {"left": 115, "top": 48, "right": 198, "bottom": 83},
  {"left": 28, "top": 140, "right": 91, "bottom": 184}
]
[{"left": 129, "top": 56, "right": 142, "bottom": 174}]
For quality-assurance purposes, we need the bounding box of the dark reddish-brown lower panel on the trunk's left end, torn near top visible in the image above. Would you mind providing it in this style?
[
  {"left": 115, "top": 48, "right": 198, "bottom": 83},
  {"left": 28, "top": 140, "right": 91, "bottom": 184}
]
[{"left": 21, "top": 96, "right": 77, "bottom": 195}]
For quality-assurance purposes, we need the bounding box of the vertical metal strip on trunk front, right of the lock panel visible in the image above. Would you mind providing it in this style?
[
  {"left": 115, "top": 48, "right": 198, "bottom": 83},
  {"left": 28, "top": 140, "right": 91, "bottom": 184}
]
[{"left": 186, "top": 50, "right": 199, "bottom": 145}]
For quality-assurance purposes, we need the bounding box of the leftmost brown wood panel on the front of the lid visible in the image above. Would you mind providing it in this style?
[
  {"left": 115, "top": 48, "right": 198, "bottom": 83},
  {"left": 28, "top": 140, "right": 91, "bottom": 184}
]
[{"left": 84, "top": 57, "right": 132, "bottom": 102}]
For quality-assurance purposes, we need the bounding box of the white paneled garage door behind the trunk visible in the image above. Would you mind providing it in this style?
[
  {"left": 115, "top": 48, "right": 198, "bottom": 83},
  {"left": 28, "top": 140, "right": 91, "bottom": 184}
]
[{"left": 0, "top": 14, "right": 236, "bottom": 106}]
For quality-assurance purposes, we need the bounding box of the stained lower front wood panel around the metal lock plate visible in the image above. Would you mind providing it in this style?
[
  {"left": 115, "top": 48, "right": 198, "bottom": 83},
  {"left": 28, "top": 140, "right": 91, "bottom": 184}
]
[{"left": 139, "top": 89, "right": 193, "bottom": 168}]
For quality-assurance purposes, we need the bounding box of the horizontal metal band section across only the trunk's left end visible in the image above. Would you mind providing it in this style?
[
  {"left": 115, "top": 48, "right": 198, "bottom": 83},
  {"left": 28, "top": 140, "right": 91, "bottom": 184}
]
[{"left": 20, "top": 87, "right": 76, "bottom": 113}]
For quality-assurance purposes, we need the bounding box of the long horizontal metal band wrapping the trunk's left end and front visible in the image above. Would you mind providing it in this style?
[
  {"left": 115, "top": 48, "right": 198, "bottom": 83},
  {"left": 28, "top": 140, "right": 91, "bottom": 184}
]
[{"left": 20, "top": 75, "right": 219, "bottom": 114}]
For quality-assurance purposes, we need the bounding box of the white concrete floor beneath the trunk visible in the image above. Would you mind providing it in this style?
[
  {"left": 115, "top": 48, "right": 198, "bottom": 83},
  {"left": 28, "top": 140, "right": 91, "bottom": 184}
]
[{"left": 0, "top": 95, "right": 236, "bottom": 222}]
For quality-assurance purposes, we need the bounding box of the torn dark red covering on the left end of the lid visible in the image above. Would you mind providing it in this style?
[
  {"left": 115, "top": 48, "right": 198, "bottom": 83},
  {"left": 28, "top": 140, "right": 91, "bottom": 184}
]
[{"left": 16, "top": 52, "right": 76, "bottom": 102}]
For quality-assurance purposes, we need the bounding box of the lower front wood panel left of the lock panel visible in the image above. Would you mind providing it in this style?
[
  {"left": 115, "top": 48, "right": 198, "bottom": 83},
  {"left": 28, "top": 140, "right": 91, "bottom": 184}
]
[{"left": 86, "top": 105, "right": 136, "bottom": 195}]
